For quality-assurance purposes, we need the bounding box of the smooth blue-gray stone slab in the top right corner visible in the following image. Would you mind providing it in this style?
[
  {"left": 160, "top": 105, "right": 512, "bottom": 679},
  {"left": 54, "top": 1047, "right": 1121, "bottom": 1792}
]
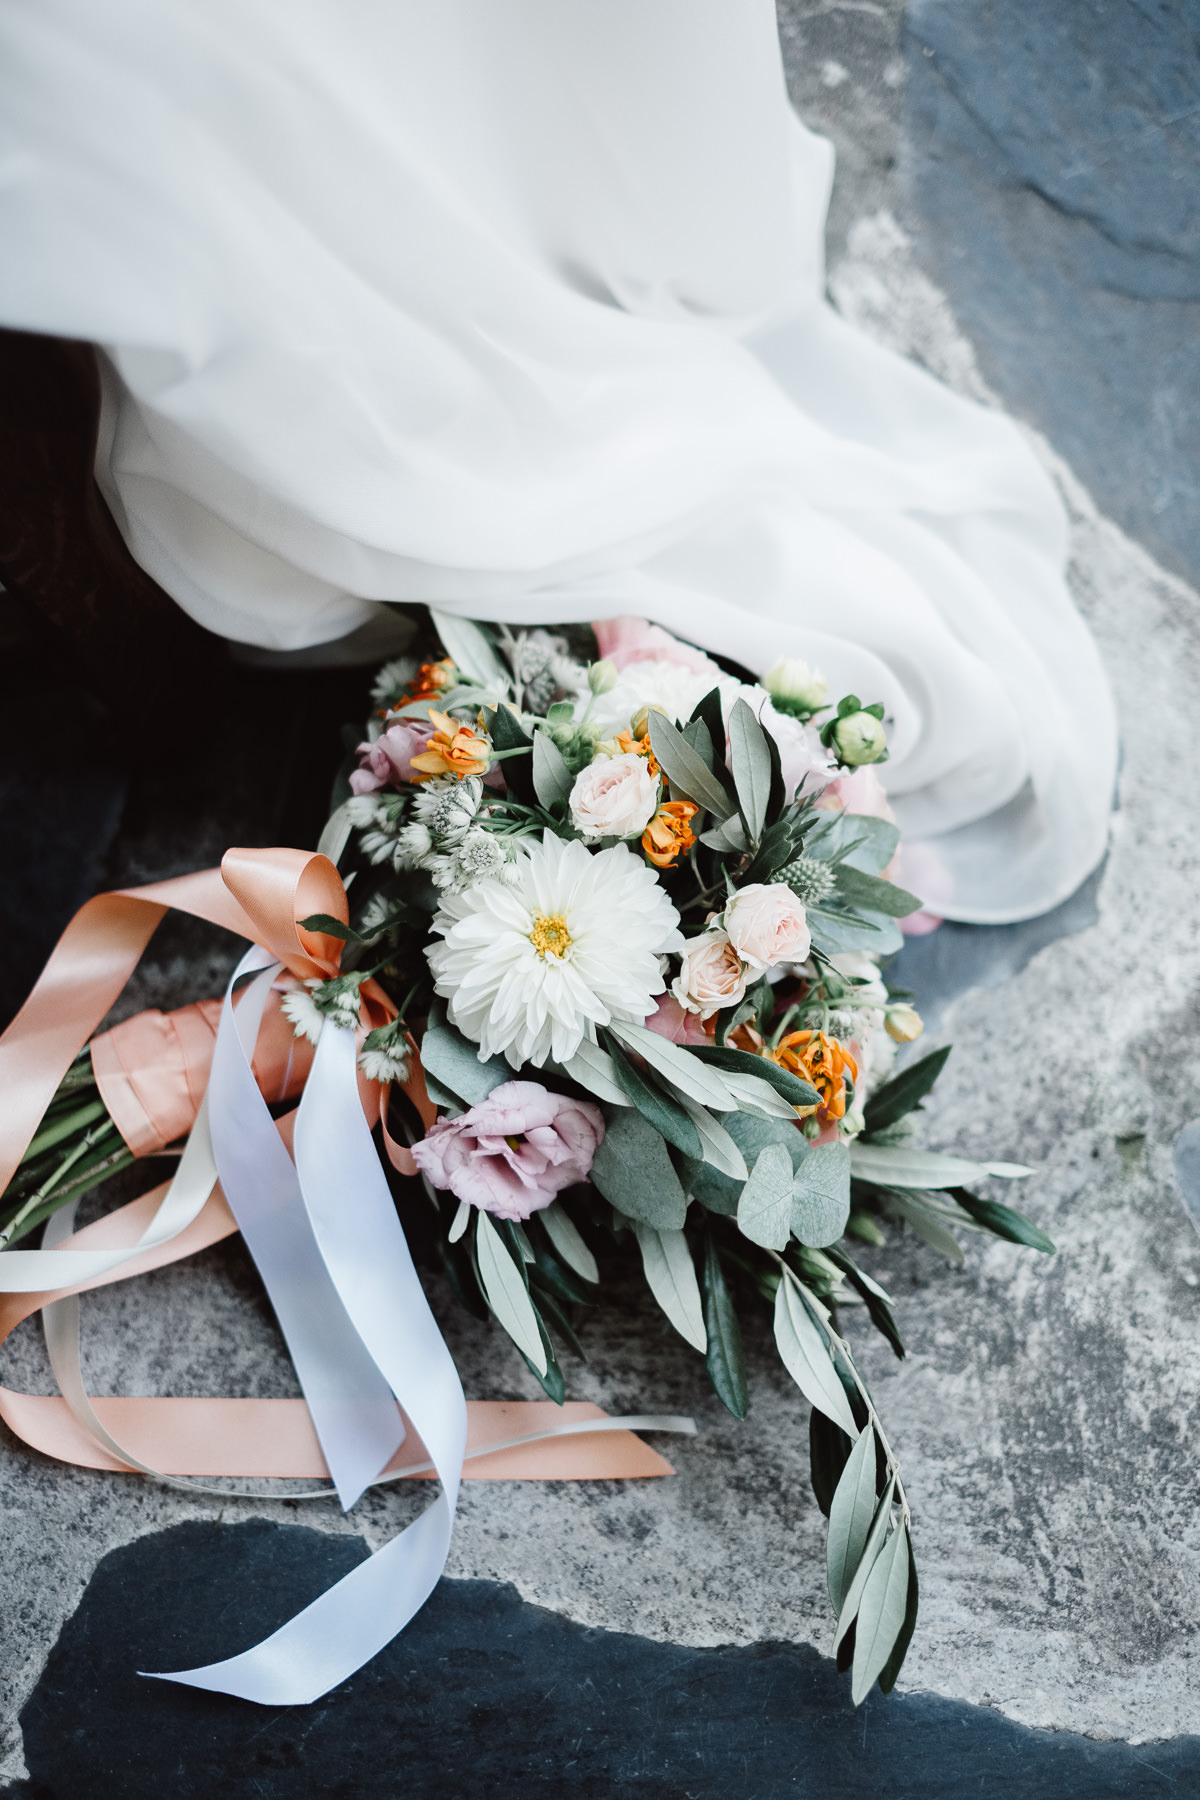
[{"left": 903, "top": 0, "right": 1200, "bottom": 580}]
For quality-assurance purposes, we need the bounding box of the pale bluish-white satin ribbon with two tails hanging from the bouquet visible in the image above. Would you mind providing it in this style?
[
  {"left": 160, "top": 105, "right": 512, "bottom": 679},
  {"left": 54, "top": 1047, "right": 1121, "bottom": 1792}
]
[{"left": 143, "top": 950, "right": 466, "bottom": 1706}]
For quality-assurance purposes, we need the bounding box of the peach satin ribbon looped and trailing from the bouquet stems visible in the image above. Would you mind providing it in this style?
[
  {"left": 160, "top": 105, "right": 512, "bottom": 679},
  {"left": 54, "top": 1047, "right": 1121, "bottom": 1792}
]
[{"left": 0, "top": 850, "right": 673, "bottom": 1481}]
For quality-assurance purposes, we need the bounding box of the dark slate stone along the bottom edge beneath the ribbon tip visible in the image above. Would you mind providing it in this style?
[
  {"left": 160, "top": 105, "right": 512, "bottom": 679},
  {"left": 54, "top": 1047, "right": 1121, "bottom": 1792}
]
[{"left": 7, "top": 1521, "right": 1200, "bottom": 1800}]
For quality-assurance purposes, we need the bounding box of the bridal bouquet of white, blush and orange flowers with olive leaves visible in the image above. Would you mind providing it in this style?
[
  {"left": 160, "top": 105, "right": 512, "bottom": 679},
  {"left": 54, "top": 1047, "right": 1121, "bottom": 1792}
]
[{"left": 0, "top": 612, "right": 1052, "bottom": 1701}]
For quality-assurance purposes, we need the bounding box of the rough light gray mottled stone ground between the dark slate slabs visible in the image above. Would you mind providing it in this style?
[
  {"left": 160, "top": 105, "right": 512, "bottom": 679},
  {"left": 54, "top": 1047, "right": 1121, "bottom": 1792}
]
[{"left": 0, "top": 0, "right": 1200, "bottom": 1778}]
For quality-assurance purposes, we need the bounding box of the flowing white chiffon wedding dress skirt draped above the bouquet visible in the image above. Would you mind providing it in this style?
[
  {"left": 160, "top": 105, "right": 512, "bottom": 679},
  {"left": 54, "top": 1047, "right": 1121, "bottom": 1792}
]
[{"left": 0, "top": 0, "right": 1115, "bottom": 922}]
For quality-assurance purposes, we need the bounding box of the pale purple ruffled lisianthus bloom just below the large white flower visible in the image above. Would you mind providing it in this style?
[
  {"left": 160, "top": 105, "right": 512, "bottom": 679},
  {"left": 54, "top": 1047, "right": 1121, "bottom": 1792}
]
[{"left": 412, "top": 1082, "right": 604, "bottom": 1219}]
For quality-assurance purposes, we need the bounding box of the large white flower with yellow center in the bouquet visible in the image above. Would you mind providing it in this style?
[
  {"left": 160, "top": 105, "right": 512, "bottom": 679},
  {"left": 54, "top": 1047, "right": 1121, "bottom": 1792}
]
[{"left": 425, "top": 832, "right": 682, "bottom": 1069}]
